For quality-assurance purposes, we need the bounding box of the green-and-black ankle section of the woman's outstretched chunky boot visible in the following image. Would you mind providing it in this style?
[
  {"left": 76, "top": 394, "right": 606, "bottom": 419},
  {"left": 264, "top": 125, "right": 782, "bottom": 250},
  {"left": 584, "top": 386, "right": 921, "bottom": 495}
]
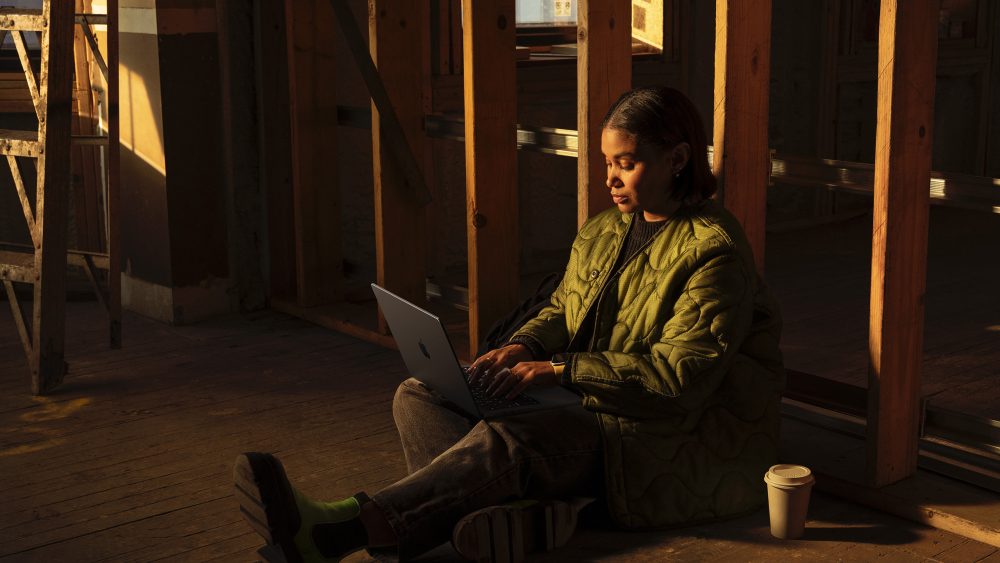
[{"left": 292, "top": 487, "right": 368, "bottom": 561}]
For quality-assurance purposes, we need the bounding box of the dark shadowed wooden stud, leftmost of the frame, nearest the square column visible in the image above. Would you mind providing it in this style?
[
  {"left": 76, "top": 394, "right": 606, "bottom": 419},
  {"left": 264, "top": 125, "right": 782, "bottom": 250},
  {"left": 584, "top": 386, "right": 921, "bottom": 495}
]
[{"left": 286, "top": 0, "right": 343, "bottom": 307}]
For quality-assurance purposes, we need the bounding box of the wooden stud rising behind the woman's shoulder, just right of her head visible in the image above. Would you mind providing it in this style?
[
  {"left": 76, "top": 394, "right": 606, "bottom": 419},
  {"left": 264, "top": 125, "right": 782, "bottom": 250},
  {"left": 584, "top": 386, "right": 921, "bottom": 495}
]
[{"left": 712, "top": 0, "right": 771, "bottom": 271}]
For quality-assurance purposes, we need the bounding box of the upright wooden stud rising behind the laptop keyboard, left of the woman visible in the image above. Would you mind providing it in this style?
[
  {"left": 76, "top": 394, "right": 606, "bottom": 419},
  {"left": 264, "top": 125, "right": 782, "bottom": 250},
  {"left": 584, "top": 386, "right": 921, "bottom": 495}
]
[{"left": 462, "top": 0, "right": 521, "bottom": 357}]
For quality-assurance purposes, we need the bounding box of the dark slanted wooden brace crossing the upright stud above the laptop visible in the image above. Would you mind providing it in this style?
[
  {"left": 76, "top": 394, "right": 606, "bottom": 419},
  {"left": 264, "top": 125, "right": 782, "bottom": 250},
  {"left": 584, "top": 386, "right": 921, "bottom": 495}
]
[{"left": 330, "top": 0, "right": 433, "bottom": 205}]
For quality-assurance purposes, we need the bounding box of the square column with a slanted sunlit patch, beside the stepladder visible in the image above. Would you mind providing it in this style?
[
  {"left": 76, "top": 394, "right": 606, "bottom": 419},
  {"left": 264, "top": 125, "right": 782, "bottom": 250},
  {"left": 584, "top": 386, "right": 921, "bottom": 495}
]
[{"left": 120, "top": 0, "right": 233, "bottom": 324}]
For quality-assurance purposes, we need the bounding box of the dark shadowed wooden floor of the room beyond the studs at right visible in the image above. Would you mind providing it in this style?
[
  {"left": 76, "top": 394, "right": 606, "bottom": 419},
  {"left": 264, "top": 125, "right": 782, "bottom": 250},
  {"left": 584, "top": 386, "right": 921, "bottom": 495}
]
[{"left": 765, "top": 206, "right": 1000, "bottom": 420}]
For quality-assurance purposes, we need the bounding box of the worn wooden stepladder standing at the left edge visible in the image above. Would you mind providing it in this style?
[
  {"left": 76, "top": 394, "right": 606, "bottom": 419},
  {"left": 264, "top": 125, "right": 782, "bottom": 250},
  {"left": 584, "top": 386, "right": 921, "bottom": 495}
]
[{"left": 0, "top": 0, "right": 121, "bottom": 395}]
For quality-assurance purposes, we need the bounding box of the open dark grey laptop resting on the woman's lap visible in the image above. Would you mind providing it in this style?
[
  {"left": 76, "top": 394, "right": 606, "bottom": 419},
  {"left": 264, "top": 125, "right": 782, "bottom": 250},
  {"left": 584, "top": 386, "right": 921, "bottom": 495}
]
[{"left": 372, "top": 283, "right": 580, "bottom": 419}]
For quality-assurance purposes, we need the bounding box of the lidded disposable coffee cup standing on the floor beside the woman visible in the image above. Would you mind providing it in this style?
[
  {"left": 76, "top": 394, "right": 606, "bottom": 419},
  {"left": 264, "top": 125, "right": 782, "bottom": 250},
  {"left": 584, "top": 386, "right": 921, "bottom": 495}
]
[{"left": 764, "top": 464, "right": 815, "bottom": 540}]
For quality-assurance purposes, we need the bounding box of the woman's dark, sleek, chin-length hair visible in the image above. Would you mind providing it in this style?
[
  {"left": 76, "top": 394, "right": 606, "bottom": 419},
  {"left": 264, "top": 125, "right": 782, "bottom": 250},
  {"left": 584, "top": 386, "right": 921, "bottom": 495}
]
[{"left": 601, "top": 87, "right": 716, "bottom": 203}]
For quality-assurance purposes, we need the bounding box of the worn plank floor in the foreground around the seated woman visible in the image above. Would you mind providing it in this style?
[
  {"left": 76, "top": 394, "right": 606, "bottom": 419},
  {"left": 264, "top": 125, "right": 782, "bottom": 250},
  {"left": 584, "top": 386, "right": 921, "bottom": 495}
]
[{"left": 0, "top": 303, "right": 1000, "bottom": 562}]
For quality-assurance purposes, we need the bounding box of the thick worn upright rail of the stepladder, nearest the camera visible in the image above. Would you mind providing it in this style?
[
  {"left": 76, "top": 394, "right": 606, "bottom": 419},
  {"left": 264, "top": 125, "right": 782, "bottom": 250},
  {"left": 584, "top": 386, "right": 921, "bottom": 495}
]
[{"left": 31, "top": 1, "right": 73, "bottom": 395}]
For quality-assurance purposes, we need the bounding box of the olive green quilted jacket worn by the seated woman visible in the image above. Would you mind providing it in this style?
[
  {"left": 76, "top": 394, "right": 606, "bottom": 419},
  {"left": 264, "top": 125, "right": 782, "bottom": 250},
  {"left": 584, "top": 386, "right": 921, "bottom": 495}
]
[{"left": 514, "top": 201, "right": 784, "bottom": 529}]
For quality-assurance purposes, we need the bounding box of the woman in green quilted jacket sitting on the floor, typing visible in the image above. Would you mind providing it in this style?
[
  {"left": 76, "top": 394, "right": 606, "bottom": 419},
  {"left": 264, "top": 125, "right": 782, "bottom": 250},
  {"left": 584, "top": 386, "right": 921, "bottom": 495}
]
[{"left": 236, "top": 88, "right": 784, "bottom": 560}]
